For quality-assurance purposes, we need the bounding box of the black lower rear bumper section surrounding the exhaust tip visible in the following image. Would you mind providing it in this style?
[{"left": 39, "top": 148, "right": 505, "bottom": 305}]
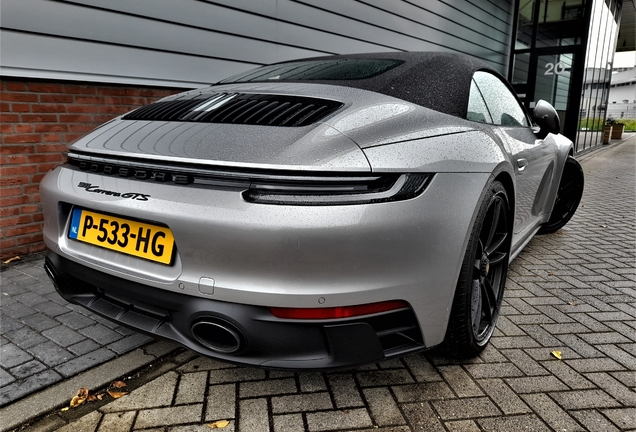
[{"left": 45, "top": 251, "right": 424, "bottom": 370}]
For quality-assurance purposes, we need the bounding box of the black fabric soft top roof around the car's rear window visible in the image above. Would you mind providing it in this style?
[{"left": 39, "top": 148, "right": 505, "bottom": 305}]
[{"left": 222, "top": 52, "right": 499, "bottom": 118}]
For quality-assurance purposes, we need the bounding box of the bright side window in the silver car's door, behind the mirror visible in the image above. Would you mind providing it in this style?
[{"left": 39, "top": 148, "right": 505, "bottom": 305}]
[{"left": 473, "top": 71, "right": 528, "bottom": 127}]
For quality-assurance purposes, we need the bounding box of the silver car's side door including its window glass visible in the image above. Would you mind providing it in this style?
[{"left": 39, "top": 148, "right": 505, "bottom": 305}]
[{"left": 469, "top": 71, "right": 555, "bottom": 236}]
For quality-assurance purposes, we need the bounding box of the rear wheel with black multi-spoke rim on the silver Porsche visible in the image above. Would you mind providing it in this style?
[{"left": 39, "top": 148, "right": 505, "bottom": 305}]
[{"left": 444, "top": 181, "right": 512, "bottom": 357}]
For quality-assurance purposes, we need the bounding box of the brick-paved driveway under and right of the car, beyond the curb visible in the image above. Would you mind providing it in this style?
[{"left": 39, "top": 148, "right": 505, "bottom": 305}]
[{"left": 4, "top": 136, "right": 636, "bottom": 432}]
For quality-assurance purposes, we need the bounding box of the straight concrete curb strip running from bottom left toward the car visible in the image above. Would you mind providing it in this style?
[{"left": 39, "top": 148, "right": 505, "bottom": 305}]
[{"left": 0, "top": 341, "right": 177, "bottom": 432}]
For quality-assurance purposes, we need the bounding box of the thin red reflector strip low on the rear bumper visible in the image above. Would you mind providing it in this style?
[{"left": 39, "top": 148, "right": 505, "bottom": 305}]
[{"left": 269, "top": 300, "right": 409, "bottom": 319}]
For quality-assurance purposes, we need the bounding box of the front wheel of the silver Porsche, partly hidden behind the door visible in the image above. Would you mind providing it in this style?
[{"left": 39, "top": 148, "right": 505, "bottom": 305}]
[{"left": 538, "top": 156, "right": 585, "bottom": 234}]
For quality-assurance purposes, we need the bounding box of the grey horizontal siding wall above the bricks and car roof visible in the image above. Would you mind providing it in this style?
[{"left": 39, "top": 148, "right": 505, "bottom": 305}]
[{"left": 0, "top": 0, "right": 514, "bottom": 87}]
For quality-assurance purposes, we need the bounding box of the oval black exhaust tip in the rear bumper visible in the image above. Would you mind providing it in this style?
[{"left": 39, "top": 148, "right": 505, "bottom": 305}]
[{"left": 190, "top": 317, "right": 244, "bottom": 354}]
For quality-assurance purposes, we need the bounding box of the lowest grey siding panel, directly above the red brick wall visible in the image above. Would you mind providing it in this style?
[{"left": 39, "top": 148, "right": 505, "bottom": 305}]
[{"left": 0, "top": 30, "right": 252, "bottom": 88}]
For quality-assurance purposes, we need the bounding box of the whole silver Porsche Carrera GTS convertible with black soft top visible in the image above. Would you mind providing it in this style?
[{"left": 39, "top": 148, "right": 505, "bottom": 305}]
[{"left": 41, "top": 53, "right": 583, "bottom": 369}]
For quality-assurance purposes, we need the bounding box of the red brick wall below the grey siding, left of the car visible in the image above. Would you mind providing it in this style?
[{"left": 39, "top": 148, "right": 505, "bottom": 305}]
[{"left": 0, "top": 79, "right": 182, "bottom": 259}]
